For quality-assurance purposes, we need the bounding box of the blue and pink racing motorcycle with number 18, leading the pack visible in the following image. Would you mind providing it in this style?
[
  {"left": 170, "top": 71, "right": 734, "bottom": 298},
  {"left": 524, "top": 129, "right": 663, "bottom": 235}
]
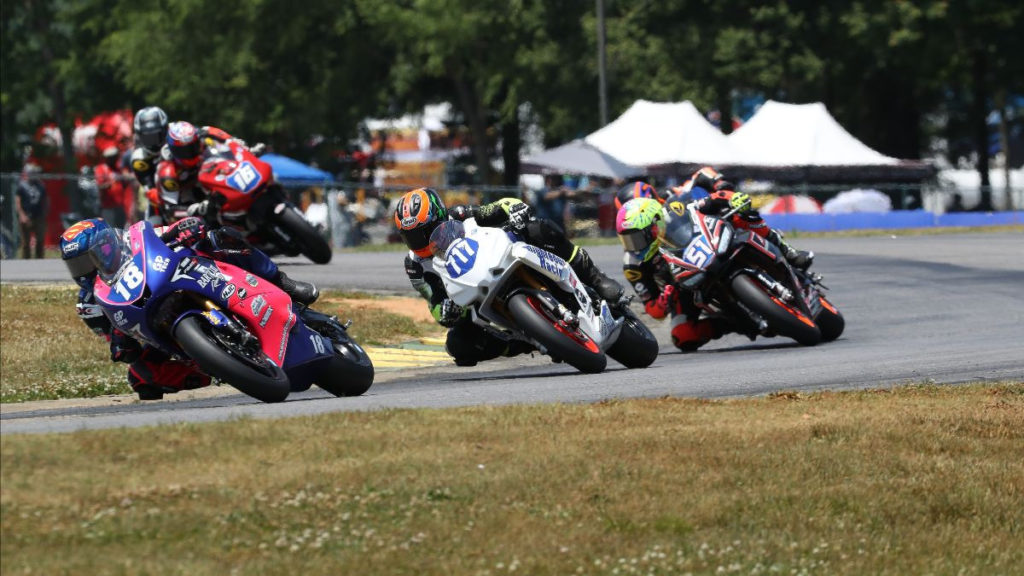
[{"left": 90, "top": 220, "right": 374, "bottom": 402}]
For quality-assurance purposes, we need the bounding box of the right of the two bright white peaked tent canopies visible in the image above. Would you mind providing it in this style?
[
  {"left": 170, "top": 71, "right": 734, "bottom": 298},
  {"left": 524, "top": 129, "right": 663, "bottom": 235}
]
[{"left": 728, "top": 100, "right": 900, "bottom": 166}]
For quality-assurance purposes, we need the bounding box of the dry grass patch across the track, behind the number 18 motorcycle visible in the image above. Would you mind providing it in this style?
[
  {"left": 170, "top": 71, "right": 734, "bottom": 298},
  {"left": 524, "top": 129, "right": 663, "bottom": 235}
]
[{"left": 0, "top": 284, "right": 436, "bottom": 402}]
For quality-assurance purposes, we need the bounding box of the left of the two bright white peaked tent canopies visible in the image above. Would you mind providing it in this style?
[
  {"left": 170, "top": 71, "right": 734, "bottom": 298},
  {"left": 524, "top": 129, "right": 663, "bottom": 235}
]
[{"left": 586, "top": 100, "right": 734, "bottom": 166}]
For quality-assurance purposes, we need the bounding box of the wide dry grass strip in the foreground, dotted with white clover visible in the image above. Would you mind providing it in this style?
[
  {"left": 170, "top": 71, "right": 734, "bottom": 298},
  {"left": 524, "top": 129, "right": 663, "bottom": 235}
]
[{"left": 0, "top": 382, "right": 1024, "bottom": 575}]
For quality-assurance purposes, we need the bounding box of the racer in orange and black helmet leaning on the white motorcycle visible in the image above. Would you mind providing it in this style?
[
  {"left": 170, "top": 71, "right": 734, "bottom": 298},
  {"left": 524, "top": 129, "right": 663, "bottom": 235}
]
[{"left": 394, "top": 189, "right": 623, "bottom": 366}]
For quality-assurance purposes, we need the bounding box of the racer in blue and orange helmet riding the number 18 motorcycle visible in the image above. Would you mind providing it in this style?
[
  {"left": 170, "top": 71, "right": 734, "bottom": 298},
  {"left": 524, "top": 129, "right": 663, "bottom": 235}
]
[{"left": 60, "top": 217, "right": 319, "bottom": 400}]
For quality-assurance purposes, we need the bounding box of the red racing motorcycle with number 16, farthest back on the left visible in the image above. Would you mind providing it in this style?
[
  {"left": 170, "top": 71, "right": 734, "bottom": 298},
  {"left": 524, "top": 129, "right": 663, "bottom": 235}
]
[{"left": 199, "top": 140, "right": 332, "bottom": 264}]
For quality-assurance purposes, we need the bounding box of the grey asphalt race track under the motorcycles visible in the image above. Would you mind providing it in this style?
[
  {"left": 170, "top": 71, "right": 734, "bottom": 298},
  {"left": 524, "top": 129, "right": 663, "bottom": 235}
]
[{"left": 0, "top": 232, "right": 1024, "bottom": 434}]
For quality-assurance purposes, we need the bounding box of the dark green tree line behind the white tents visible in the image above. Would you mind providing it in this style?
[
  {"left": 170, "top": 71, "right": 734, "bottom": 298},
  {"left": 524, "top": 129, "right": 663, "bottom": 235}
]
[{"left": 0, "top": 0, "right": 1024, "bottom": 192}]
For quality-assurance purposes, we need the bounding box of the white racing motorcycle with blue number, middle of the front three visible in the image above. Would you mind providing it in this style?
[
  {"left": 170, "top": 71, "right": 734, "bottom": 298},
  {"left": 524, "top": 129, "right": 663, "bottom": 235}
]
[{"left": 430, "top": 218, "right": 657, "bottom": 373}]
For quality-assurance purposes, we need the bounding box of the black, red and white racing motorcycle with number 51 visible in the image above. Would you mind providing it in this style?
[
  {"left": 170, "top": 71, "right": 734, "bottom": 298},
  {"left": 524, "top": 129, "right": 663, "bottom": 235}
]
[{"left": 660, "top": 201, "right": 845, "bottom": 345}]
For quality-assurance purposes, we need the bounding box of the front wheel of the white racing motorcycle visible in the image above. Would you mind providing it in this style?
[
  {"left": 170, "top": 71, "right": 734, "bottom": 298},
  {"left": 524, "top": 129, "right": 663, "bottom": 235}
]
[{"left": 508, "top": 292, "right": 608, "bottom": 373}]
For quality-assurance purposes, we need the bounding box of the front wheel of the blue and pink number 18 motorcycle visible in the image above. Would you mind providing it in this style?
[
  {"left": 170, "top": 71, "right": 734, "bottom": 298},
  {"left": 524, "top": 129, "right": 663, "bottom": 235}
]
[{"left": 173, "top": 316, "right": 291, "bottom": 402}]
